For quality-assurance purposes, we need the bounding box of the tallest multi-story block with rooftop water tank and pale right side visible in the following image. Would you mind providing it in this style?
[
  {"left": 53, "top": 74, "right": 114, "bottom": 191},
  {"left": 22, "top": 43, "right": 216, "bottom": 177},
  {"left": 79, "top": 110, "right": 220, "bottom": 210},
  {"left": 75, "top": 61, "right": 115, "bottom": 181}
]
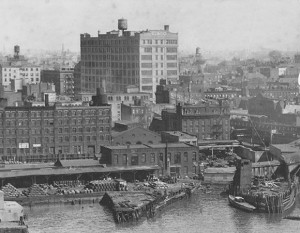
[{"left": 76, "top": 19, "right": 178, "bottom": 98}]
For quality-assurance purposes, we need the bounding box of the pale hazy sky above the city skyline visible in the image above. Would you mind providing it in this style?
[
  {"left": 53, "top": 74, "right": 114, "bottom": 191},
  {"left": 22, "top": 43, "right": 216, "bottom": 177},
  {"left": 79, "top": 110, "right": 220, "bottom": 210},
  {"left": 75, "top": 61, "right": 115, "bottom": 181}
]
[{"left": 0, "top": 0, "right": 300, "bottom": 52}]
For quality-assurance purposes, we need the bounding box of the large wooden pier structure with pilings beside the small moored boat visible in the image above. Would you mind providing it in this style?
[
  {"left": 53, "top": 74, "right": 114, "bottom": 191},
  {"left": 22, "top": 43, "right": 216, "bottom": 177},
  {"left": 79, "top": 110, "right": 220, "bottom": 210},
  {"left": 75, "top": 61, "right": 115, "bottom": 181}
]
[{"left": 229, "top": 160, "right": 300, "bottom": 215}]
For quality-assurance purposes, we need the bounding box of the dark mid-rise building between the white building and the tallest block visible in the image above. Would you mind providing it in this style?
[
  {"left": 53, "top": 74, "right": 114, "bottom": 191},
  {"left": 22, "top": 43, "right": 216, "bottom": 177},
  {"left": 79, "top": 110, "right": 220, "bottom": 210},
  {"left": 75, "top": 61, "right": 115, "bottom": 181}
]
[{"left": 41, "top": 67, "right": 74, "bottom": 98}]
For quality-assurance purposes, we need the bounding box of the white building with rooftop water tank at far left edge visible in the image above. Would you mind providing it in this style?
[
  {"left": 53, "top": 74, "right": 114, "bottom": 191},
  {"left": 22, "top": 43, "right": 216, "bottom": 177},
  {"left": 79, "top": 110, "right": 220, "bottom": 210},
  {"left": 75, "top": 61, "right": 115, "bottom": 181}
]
[{"left": 0, "top": 46, "right": 41, "bottom": 91}]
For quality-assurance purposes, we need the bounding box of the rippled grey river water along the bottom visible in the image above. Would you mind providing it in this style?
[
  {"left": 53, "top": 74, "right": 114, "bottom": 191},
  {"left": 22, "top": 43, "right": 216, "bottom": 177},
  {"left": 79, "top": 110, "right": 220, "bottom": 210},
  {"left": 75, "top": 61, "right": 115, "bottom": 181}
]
[{"left": 25, "top": 191, "right": 300, "bottom": 233}]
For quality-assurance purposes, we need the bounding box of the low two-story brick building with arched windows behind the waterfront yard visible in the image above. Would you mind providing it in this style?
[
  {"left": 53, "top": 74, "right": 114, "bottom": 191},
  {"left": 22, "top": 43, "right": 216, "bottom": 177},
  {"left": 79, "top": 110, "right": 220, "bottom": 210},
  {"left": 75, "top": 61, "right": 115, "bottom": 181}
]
[{"left": 100, "top": 143, "right": 200, "bottom": 177}]
